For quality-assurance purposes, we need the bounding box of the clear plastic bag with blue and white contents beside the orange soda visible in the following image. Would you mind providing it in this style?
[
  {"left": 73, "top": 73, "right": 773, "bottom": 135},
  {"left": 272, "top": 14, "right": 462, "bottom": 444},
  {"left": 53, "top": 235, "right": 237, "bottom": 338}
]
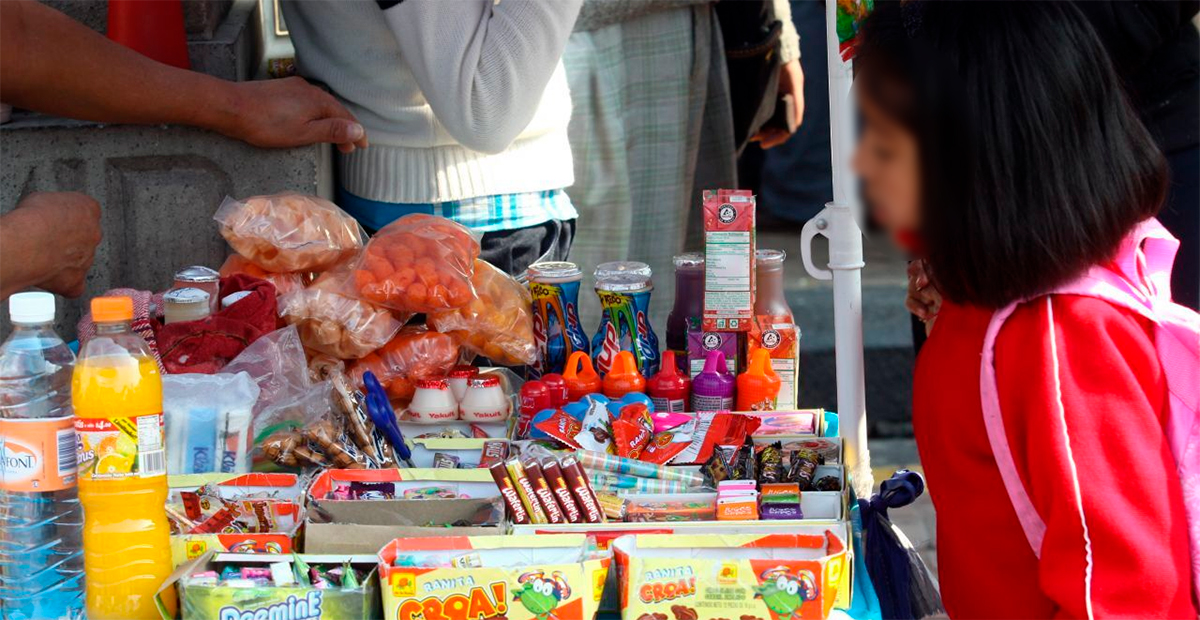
[{"left": 162, "top": 372, "right": 259, "bottom": 474}]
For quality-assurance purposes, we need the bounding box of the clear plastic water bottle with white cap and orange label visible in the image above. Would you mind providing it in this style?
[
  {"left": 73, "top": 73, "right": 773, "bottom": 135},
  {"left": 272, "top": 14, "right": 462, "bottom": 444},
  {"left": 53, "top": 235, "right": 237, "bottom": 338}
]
[{"left": 0, "top": 293, "right": 84, "bottom": 620}]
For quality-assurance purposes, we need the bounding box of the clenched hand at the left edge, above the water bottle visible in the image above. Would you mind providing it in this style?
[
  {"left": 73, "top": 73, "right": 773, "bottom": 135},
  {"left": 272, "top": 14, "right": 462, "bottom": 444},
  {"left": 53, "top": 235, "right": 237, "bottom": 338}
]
[{"left": 0, "top": 192, "right": 101, "bottom": 297}]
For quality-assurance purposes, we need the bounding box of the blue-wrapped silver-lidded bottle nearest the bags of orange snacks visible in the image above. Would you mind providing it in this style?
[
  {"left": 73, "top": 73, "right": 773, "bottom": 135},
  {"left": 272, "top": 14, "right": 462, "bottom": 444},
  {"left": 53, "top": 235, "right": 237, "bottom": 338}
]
[{"left": 526, "top": 263, "right": 590, "bottom": 379}]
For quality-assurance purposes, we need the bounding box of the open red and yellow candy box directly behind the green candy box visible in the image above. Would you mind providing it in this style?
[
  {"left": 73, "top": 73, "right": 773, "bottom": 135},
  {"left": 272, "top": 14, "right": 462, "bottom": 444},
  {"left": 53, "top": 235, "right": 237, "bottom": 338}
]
[{"left": 167, "top": 474, "right": 304, "bottom": 566}]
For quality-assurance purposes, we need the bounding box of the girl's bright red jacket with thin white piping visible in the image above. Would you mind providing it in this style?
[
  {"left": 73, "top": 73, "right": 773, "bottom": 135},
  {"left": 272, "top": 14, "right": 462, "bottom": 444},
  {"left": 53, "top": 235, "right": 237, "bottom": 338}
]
[{"left": 913, "top": 295, "right": 1196, "bottom": 618}]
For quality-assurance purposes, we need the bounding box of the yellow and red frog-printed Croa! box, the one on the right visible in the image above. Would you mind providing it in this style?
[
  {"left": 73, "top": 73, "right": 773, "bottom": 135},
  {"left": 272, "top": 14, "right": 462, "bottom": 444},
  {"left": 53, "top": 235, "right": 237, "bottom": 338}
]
[{"left": 612, "top": 530, "right": 850, "bottom": 620}]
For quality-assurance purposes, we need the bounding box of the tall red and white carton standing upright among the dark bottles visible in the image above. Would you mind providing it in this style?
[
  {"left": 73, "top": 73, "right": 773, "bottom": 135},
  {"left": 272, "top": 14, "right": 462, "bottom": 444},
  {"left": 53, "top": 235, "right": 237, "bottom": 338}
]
[{"left": 703, "top": 189, "right": 755, "bottom": 331}]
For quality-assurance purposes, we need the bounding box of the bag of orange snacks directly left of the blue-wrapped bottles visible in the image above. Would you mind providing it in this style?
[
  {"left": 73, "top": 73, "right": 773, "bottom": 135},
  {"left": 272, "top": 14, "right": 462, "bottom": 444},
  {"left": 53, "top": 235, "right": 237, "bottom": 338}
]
[{"left": 428, "top": 260, "right": 538, "bottom": 366}]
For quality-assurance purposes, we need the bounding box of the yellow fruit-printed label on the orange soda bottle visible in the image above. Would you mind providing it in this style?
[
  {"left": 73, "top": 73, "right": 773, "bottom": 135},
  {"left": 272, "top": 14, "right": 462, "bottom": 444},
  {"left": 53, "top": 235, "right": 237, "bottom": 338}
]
[{"left": 76, "top": 413, "right": 167, "bottom": 480}]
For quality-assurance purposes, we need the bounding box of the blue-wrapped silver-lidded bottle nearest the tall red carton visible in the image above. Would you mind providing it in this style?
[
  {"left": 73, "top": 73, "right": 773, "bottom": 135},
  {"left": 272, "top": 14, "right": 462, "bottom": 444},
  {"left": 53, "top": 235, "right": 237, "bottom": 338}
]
[{"left": 592, "top": 261, "right": 661, "bottom": 377}]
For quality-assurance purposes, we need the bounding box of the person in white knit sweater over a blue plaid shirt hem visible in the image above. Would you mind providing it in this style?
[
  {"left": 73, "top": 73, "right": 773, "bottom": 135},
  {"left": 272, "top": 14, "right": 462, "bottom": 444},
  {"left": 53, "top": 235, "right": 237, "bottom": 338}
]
[{"left": 283, "top": 0, "right": 581, "bottom": 273}]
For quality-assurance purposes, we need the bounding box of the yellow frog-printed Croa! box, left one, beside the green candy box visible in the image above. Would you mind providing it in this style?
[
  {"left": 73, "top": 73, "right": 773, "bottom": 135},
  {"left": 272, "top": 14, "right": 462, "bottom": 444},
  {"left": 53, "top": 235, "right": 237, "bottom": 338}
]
[{"left": 379, "top": 535, "right": 610, "bottom": 620}]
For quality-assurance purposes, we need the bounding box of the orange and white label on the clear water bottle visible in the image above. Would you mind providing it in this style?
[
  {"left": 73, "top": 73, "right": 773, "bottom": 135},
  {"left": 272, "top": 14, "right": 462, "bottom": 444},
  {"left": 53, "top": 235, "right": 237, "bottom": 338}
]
[{"left": 0, "top": 415, "right": 77, "bottom": 493}]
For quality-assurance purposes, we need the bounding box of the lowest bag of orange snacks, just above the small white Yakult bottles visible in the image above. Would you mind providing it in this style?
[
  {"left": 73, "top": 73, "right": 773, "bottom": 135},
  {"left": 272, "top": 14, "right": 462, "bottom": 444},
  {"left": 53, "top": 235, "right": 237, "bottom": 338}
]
[{"left": 348, "top": 325, "right": 458, "bottom": 403}]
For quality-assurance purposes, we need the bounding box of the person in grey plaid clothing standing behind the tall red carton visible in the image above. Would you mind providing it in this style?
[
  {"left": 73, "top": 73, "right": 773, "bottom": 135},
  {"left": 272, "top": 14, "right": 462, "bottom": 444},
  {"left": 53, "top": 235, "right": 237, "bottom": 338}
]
[{"left": 563, "top": 0, "right": 803, "bottom": 325}]
